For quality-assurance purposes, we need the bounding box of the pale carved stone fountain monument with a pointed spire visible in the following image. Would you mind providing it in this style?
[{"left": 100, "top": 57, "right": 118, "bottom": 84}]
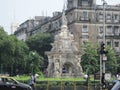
[{"left": 46, "top": 12, "right": 84, "bottom": 77}]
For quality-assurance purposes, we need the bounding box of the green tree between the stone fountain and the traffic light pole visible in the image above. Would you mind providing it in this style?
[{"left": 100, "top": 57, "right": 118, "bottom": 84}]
[{"left": 81, "top": 42, "right": 99, "bottom": 74}]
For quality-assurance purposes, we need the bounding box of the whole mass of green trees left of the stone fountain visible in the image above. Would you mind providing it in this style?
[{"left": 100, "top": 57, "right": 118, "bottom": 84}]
[{"left": 0, "top": 27, "right": 51, "bottom": 75}]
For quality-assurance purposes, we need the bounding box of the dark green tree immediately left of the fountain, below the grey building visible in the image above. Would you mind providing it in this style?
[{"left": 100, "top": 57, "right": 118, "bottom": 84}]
[{"left": 26, "top": 33, "right": 53, "bottom": 69}]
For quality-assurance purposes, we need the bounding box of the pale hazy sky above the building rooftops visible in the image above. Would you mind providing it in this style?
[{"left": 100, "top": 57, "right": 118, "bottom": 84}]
[{"left": 0, "top": 0, "right": 120, "bottom": 34}]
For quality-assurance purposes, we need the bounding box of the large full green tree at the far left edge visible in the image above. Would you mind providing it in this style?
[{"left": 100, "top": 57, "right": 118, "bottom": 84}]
[{"left": 0, "top": 29, "right": 29, "bottom": 74}]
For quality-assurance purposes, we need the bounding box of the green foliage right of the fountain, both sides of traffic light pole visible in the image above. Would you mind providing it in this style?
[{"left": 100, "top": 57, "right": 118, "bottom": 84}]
[{"left": 81, "top": 42, "right": 118, "bottom": 74}]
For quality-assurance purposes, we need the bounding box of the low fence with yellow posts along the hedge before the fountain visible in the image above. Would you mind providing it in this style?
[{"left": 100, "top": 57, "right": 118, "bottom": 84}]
[{"left": 35, "top": 81, "right": 100, "bottom": 90}]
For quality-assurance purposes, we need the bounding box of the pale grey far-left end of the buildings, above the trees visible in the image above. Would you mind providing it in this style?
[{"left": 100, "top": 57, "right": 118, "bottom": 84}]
[{"left": 14, "top": 16, "right": 46, "bottom": 41}]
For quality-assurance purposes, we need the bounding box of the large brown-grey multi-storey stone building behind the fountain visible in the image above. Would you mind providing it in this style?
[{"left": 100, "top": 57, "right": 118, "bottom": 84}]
[{"left": 14, "top": 0, "right": 120, "bottom": 54}]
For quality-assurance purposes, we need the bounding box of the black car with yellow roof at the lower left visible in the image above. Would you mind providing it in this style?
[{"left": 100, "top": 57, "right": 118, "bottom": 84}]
[{"left": 0, "top": 76, "right": 32, "bottom": 90}]
